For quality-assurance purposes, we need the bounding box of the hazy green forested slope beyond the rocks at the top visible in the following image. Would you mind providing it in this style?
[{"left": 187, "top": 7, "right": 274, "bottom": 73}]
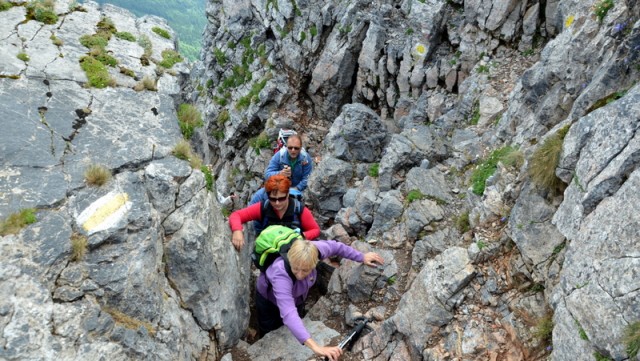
[{"left": 85, "top": 0, "right": 206, "bottom": 61}]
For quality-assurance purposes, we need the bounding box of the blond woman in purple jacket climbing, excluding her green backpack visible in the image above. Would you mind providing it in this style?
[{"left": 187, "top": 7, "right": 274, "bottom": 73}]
[{"left": 256, "top": 239, "right": 384, "bottom": 361}]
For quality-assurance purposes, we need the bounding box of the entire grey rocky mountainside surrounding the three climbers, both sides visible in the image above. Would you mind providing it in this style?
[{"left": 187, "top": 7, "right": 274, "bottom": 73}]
[{"left": 0, "top": 0, "right": 640, "bottom": 360}]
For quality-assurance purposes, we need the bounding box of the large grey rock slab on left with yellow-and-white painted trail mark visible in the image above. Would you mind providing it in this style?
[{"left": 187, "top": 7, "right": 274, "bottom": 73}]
[{"left": 0, "top": 1, "right": 242, "bottom": 360}]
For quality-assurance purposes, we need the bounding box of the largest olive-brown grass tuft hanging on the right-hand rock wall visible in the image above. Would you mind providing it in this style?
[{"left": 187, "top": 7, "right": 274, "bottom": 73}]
[{"left": 527, "top": 126, "right": 569, "bottom": 191}]
